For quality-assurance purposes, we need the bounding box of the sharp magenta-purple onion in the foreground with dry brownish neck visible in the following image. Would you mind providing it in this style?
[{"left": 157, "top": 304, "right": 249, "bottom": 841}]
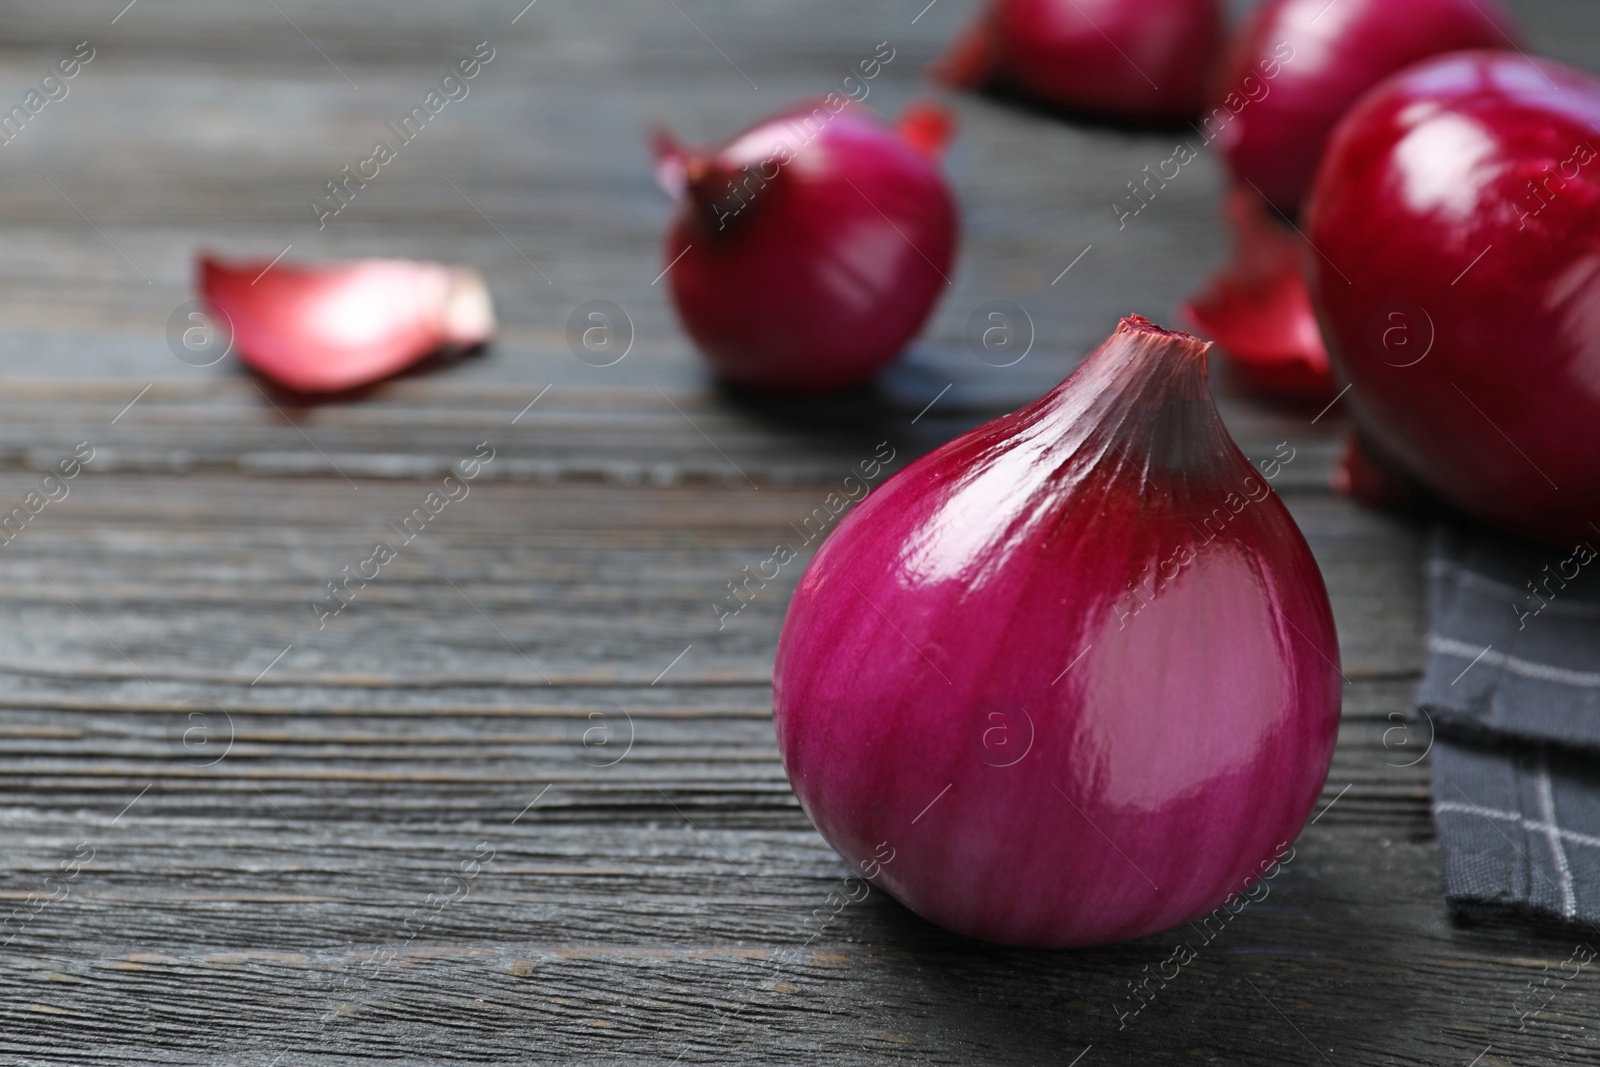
[{"left": 773, "top": 317, "right": 1339, "bottom": 947}]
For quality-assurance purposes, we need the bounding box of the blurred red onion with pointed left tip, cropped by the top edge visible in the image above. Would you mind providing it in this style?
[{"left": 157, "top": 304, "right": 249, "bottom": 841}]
[{"left": 936, "top": 0, "right": 1222, "bottom": 122}]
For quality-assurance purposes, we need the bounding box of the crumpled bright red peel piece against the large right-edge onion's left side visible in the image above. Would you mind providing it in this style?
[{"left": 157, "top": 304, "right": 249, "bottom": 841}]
[{"left": 1179, "top": 186, "right": 1336, "bottom": 398}]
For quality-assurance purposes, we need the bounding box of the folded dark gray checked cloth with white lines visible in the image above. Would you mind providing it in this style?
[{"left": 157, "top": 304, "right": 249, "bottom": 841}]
[{"left": 1418, "top": 522, "right": 1600, "bottom": 923}]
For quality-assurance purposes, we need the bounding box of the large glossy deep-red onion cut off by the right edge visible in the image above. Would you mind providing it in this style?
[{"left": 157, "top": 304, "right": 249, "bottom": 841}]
[{"left": 1307, "top": 51, "right": 1600, "bottom": 541}]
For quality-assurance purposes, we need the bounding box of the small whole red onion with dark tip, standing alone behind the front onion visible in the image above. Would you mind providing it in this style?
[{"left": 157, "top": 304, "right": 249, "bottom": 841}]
[{"left": 656, "top": 93, "right": 957, "bottom": 394}]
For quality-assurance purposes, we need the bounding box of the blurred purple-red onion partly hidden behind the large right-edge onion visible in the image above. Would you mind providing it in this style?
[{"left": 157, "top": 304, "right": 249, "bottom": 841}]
[{"left": 1202, "top": 0, "right": 1522, "bottom": 216}]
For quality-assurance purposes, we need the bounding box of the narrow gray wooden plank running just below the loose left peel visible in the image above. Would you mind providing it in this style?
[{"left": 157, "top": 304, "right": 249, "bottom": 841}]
[{"left": 0, "top": 377, "right": 1342, "bottom": 508}]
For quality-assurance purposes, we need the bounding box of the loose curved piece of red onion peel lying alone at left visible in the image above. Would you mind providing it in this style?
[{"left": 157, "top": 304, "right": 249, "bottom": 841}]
[{"left": 200, "top": 256, "right": 494, "bottom": 394}]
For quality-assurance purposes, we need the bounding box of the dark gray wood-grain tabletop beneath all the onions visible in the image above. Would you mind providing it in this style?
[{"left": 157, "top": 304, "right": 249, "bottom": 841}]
[{"left": 0, "top": 0, "right": 1600, "bottom": 1067}]
